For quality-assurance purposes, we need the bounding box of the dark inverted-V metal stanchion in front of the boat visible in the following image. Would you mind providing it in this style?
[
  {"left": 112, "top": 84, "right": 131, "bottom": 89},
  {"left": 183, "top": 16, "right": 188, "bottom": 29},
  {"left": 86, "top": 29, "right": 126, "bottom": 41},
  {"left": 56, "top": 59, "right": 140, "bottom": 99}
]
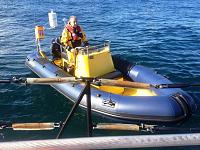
[{"left": 56, "top": 78, "right": 93, "bottom": 139}]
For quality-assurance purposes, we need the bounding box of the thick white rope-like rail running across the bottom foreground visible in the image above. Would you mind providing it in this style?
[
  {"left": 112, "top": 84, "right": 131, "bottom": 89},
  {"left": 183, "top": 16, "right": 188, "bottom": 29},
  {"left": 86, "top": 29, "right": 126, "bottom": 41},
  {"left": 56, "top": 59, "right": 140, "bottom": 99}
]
[{"left": 0, "top": 133, "right": 200, "bottom": 150}]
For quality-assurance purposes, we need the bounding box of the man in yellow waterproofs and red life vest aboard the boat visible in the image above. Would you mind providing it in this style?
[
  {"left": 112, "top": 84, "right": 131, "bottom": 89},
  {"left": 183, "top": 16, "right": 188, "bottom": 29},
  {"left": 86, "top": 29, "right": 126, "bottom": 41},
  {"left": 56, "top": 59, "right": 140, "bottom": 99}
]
[{"left": 61, "top": 16, "right": 88, "bottom": 64}]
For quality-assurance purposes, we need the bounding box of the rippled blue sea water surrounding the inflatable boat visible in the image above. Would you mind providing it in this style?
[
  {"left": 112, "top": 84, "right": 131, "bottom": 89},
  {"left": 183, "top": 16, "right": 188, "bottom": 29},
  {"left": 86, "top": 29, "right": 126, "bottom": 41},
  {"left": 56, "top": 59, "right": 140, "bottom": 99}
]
[{"left": 0, "top": 0, "right": 200, "bottom": 149}]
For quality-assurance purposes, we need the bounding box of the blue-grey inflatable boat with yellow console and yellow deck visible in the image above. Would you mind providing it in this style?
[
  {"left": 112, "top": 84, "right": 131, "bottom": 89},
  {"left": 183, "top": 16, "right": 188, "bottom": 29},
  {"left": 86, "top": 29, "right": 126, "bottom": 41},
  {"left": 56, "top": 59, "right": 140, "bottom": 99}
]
[{"left": 26, "top": 43, "right": 196, "bottom": 123}]
